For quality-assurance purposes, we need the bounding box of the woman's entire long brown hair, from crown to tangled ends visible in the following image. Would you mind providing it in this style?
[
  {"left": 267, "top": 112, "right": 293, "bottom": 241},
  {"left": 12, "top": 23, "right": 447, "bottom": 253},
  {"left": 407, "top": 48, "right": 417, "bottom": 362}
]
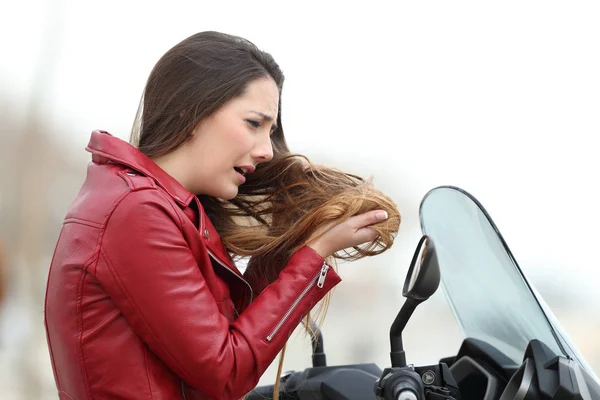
[{"left": 131, "top": 32, "right": 400, "bottom": 399}]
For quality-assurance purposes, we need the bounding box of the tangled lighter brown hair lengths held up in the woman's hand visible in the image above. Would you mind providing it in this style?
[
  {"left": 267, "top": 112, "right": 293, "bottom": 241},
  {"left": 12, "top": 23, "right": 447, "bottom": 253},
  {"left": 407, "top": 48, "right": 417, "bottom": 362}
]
[{"left": 201, "top": 154, "right": 400, "bottom": 288}]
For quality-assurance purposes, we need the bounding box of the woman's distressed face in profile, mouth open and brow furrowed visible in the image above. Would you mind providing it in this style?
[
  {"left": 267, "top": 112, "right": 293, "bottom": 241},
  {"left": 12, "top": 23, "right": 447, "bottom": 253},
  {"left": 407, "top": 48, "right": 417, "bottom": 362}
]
[{"left": 186, "top": 78, "right": 279, "bottom": 199}]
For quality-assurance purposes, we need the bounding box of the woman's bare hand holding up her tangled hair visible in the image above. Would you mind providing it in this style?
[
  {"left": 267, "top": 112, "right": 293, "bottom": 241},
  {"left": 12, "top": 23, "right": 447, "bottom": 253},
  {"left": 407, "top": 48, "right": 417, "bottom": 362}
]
[{"left": 308, "top": 210, "right": 388, "bottom": 258}]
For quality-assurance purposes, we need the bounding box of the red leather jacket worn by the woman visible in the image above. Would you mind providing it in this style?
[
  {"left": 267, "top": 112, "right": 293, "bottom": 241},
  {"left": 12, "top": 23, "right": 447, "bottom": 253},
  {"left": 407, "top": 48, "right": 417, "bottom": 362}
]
[{"left": 44, "top": 131, "right": 340, "bottom": 400}]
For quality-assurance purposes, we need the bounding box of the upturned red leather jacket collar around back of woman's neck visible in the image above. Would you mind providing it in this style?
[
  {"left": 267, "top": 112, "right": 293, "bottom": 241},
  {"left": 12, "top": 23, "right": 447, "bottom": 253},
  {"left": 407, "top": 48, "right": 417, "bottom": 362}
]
[{"left": 85, "top": 130, "right": 195, "bottom": 206}]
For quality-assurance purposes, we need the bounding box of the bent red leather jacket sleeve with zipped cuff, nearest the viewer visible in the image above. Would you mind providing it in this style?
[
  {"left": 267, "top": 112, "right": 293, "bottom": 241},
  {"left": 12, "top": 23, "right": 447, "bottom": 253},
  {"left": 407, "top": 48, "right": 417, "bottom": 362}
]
[{"left": 96, "top": 189, "right": 341, "bottom": 399}]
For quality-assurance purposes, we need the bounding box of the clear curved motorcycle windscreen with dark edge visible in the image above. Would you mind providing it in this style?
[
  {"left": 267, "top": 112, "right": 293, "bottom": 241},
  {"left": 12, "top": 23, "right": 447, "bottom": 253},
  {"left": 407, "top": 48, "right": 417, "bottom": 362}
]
[{"left": 420, "top": 187, "right": 593, "bottom": 375}]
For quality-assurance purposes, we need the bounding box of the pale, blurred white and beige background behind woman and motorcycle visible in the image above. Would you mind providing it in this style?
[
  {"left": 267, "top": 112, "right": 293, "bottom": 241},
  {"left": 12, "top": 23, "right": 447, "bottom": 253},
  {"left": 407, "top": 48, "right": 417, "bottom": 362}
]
[{"left": 0, "top": 0, "right": 600, "bottom": 399}]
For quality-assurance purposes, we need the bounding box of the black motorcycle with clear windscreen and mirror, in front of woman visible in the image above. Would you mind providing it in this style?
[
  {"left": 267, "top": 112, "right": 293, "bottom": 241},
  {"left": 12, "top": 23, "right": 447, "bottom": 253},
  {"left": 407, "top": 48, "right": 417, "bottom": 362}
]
[{"left": 246, "top": 186, "right": 600, "bottom": 400}]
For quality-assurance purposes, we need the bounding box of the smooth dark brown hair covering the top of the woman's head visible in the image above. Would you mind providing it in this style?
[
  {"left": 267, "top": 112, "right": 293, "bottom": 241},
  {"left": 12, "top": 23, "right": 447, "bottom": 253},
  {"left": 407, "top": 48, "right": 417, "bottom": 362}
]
[{"left": 131, "top": 31, "right": 288, "bottom": 158}]
